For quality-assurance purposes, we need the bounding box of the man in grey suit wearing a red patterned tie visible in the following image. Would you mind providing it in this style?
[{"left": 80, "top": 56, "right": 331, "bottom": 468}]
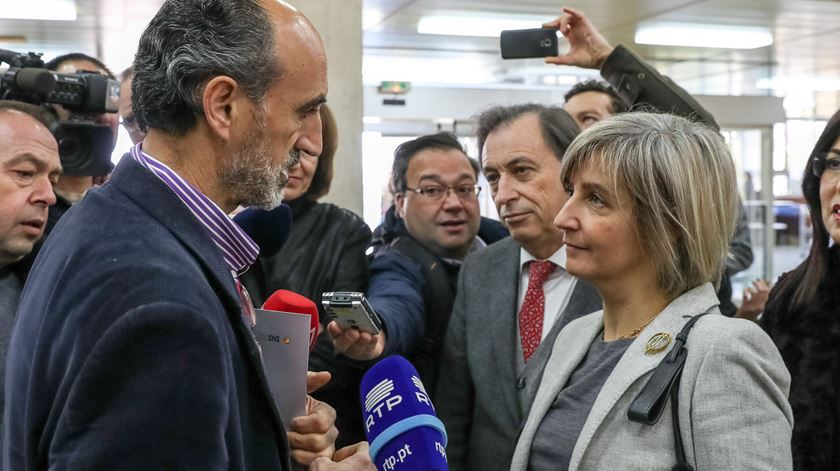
[{"left": 435, "top": 104, "right": 601, "bottom": 471}]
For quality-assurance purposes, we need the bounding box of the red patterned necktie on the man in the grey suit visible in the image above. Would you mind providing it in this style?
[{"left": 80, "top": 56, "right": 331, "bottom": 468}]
[{"left": 519, "top": 260, "right": 557, "bottom": 362}]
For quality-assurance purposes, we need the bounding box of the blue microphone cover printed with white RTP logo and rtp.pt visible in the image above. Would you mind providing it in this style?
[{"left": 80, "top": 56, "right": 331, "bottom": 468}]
[{"left": 361, "top": 355, "right": 449, "bottom": 471}]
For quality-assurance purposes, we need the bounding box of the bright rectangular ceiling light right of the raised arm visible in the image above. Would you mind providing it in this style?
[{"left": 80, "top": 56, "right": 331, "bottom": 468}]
[{"left": 635, "top": 23, "right": 773, "bottom": 49}]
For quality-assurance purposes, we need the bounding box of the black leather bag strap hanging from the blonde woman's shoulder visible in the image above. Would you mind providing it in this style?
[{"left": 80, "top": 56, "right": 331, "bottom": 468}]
[{"left": 627, "top": 309, "right": 711, "bottom": 471}]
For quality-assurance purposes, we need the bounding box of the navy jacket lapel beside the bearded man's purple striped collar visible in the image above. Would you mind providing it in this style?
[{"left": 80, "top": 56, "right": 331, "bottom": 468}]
[{"left": 110, "top": 158, "right": 286, "bottom": 444}]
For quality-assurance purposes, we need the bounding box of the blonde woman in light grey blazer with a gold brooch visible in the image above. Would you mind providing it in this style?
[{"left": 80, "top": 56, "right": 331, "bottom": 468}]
[{"left": 512, "top": 113, "right": 793, "bottom": 471}]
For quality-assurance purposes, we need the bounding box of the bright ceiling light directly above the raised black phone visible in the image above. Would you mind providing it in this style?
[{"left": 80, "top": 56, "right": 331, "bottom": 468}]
[{"left": 417, "top": 14, "right": 550, "bottom": 38}]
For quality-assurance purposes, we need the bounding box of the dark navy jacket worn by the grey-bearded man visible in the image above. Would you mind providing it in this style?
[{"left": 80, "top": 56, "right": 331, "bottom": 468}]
[{"left": 3, "top": 157, "right": 290, "bottom": 470}]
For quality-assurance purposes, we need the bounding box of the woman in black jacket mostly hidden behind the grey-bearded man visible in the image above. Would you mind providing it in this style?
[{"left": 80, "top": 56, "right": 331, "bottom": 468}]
[{"left": 243, "top": 106, "right": 371, "bottom": 448}]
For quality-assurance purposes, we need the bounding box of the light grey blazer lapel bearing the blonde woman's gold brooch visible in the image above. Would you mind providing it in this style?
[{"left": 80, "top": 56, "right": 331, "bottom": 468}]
[{"left": 564, "top": 283, "right": 717, "bottom": 471}]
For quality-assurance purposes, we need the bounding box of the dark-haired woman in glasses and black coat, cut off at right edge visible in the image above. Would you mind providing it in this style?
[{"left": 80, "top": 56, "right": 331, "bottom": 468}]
[{"left": 761, "top": 111, "right": 840, "bottom": 470}]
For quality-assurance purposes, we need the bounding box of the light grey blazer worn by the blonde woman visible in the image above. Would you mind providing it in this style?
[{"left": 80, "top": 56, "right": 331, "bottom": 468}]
[{"left": 511, "top": 283, "right": 793, "bottom": 471}]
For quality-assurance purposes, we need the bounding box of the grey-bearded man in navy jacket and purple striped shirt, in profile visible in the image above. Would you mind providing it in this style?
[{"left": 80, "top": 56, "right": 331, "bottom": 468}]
[{"left": 3, "top": 0, "right": 373, "bottom": 470}]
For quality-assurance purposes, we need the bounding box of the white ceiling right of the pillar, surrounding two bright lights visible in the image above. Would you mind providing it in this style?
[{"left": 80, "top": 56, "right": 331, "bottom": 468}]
[{"left": 364, "top": 0, "right": 840, "bottom": 94}]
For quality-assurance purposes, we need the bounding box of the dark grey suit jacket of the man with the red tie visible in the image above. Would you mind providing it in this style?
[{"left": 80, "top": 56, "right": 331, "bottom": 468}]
[{"left": 435, "top": 238, "right": 601, "bottom": 471}]
